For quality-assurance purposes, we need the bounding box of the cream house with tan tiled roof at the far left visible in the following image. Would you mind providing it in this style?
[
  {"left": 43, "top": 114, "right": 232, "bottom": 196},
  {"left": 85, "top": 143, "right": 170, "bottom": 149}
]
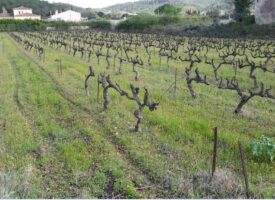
[{"left": 0, "top": 6, "right": 41, "bottom": 20}]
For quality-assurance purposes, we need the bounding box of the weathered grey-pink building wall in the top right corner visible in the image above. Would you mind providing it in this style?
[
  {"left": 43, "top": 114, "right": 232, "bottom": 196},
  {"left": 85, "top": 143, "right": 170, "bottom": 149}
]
[{"left": 255, "top": 0, "right": 275, "bottom": 24}]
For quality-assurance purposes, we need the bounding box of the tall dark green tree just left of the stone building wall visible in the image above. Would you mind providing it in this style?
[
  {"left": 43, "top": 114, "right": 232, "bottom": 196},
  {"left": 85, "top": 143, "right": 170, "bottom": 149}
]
[{"left": 234, "top": 0, "right": 253, "bottom": 22}]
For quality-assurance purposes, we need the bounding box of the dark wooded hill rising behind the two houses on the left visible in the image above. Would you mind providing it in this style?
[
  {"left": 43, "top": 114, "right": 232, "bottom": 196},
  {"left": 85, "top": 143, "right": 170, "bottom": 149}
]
[{"left": 0, "top": 0, "right": 95, "bottom": 18}]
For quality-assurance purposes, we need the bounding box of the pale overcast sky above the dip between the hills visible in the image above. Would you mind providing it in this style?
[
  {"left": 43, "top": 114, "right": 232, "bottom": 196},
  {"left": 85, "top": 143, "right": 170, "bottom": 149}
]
[{"left": 48, "top": 0, "right": 139, "bottom": 8}]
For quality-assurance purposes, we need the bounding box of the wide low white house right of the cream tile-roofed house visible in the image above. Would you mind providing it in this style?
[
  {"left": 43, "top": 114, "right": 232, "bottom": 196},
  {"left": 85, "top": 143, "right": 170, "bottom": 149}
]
[{"left": 49, "top": 10, "right": 83, "bottom": 22}]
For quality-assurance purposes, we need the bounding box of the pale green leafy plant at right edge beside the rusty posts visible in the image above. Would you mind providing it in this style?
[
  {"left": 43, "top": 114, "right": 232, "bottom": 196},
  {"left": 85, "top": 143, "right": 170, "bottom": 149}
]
[{"left": 251, "top": 135, "right": 275, "bottom": 163}]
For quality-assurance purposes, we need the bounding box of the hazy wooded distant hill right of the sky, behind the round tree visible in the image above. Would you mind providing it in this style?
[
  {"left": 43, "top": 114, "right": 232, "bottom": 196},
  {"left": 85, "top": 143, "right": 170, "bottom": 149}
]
[{"left": 104, "top": 0, "right": 231, "bottom": 13}]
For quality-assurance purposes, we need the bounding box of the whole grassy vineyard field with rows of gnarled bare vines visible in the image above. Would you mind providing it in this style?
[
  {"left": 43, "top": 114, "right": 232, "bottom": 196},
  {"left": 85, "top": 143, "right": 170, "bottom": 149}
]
[{"left": 0, "top": 32, "right": 275, "bottom": 198}]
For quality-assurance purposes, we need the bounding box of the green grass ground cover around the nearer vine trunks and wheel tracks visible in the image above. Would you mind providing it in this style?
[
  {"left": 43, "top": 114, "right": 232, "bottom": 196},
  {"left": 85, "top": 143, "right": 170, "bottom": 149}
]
[{"left": 0, "top": 34, "right": 275, "bottom": 198}]
